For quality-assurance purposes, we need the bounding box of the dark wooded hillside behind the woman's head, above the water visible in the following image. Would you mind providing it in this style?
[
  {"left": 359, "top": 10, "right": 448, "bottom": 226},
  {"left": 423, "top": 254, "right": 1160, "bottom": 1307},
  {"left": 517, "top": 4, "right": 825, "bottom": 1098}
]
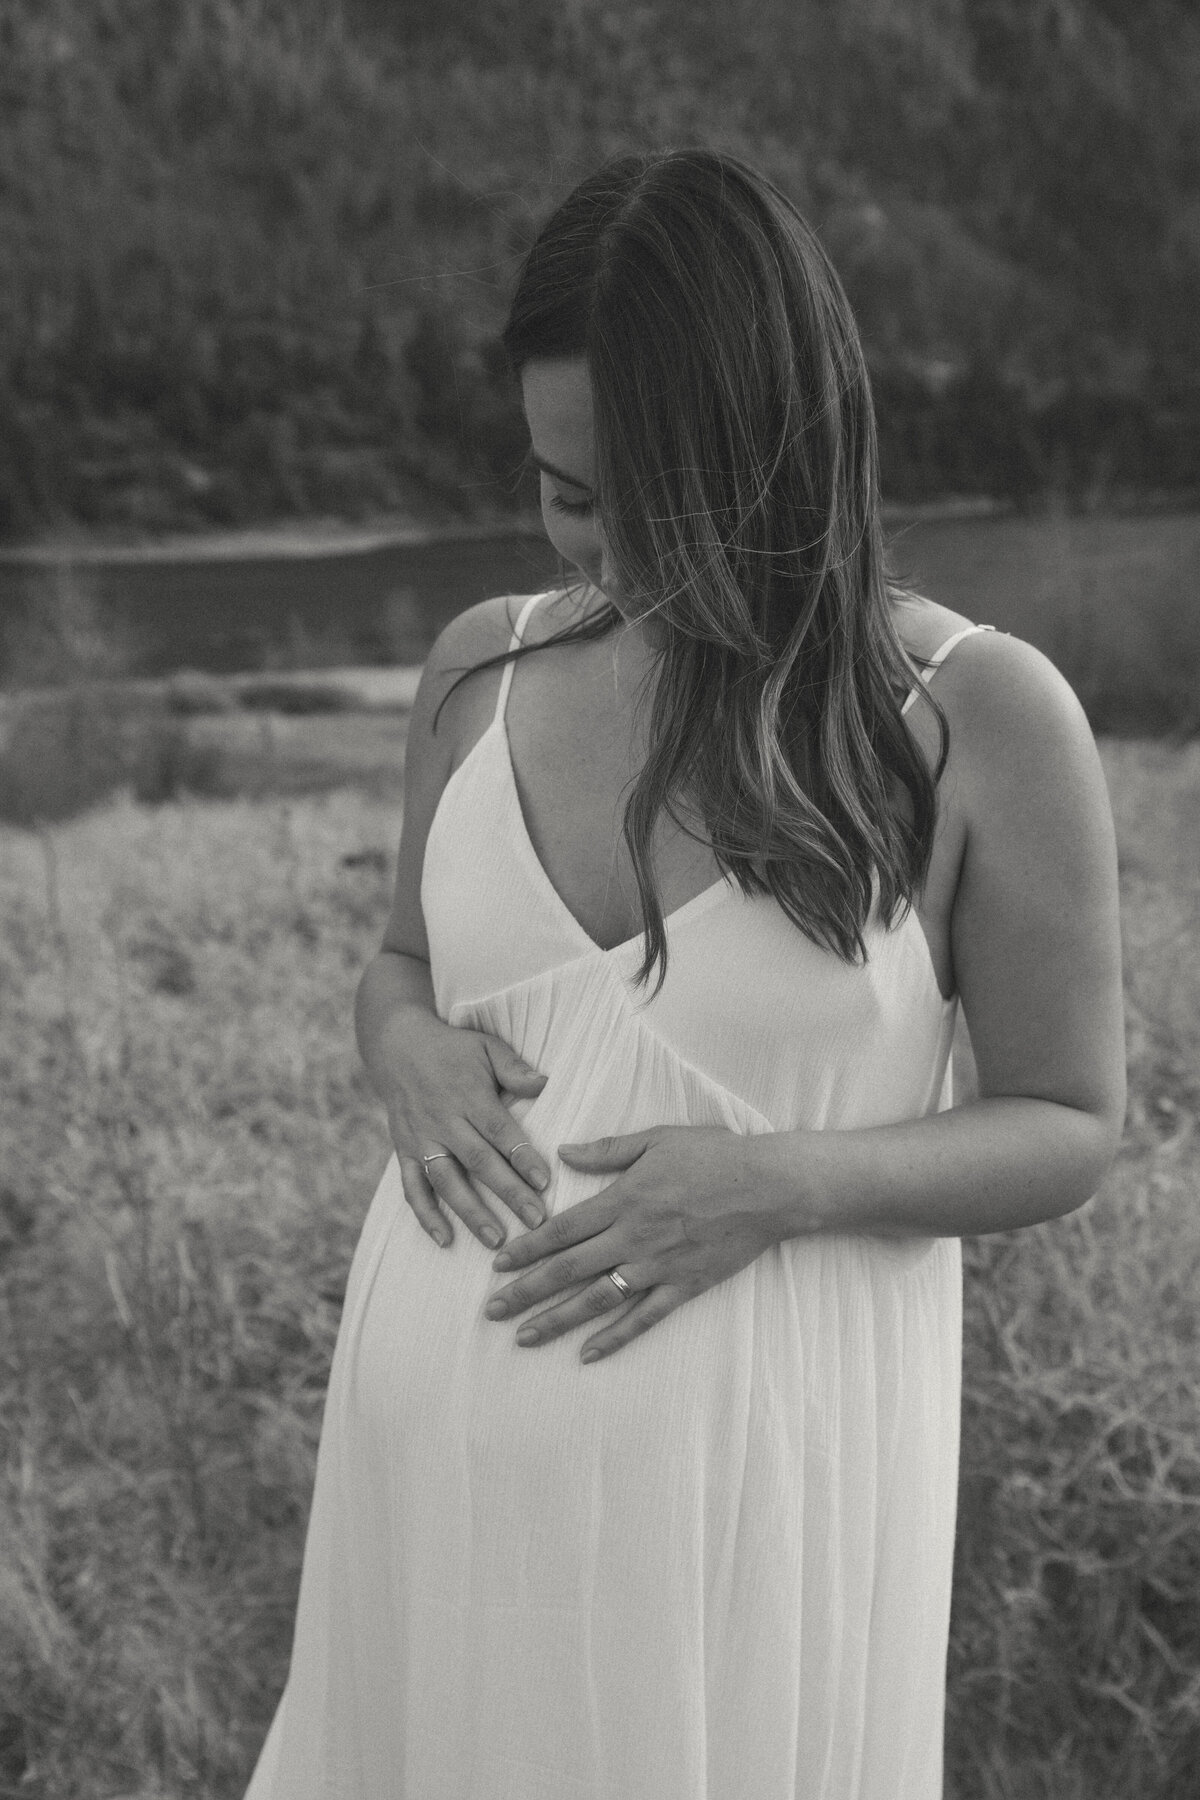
[{"left": 0, "top": 0, "right": 1200, "bottom": 540}]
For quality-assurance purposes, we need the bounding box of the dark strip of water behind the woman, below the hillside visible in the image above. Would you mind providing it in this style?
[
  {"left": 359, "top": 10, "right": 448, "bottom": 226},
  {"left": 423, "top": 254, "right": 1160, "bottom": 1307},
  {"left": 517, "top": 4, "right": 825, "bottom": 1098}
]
[{"left": 0, "top": 513, "right": 1200, "bottom": 734}]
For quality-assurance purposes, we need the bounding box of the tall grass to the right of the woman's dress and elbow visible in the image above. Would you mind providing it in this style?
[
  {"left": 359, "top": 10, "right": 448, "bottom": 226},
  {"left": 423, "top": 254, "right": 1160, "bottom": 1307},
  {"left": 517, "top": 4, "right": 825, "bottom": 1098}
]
[{"left": 950, "top": 742, "right": 1200, "bottom": 1800}]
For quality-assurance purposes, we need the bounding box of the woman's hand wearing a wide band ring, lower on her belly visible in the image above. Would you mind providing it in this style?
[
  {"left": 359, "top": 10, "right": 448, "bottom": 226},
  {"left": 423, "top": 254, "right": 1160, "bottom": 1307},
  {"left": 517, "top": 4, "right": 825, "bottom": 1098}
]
[{"left": 486, "top": 1125, "right": 779, "bottom": 1361}]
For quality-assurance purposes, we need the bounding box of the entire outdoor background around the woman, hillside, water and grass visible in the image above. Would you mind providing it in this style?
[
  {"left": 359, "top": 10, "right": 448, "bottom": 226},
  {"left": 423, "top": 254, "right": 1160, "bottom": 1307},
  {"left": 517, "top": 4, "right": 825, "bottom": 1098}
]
[{"left": 0, "top": 0, "right": 1200, "bottom": 1800}]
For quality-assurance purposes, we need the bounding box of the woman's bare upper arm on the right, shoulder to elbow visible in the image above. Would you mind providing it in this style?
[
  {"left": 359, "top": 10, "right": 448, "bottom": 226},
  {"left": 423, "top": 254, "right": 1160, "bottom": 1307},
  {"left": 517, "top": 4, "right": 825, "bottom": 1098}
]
[{"left": 934, "top": 615, "right": 1124, "bottom": 1143}]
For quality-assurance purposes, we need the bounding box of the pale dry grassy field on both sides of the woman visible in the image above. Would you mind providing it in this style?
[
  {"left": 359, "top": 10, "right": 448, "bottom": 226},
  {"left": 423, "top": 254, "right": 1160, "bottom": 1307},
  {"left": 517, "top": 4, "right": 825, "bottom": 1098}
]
[{"left": 0, "top": 722, "right": 1200, "bottom": 1800}]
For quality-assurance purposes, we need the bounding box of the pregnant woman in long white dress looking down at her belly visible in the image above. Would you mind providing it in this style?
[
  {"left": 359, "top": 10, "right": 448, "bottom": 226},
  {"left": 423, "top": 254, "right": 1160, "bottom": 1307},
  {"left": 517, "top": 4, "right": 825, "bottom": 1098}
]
[{"left": 250, "top": 151, "right": 1124, "bottom": 1800}]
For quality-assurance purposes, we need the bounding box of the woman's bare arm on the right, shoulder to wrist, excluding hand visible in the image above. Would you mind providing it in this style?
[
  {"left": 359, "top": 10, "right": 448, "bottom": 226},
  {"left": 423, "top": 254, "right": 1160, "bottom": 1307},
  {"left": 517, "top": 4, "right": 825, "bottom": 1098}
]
[{"left": 747, "top": 637, "right": 1124, "bottom": 1237}]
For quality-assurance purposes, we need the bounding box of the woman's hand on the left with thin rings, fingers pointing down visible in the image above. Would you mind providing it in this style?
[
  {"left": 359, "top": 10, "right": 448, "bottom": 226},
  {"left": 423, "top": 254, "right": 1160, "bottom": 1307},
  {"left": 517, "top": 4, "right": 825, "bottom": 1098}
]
[{"left": 381, "top": 1006, "right": 551, "bottom": 1249}]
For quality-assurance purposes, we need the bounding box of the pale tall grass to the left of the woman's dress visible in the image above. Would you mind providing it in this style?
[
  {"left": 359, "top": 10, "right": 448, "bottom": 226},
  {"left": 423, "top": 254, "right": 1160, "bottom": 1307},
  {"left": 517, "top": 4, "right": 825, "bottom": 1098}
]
[{"left": 0, "top": 794, "right": 385, "bottom": 1800}]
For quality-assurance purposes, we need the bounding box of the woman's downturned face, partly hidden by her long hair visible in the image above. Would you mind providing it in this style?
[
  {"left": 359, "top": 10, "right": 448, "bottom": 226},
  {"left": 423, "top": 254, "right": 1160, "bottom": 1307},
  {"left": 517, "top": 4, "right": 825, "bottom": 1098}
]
[{"left": 522, "top": 356, "right": 613, "bottom": 599}]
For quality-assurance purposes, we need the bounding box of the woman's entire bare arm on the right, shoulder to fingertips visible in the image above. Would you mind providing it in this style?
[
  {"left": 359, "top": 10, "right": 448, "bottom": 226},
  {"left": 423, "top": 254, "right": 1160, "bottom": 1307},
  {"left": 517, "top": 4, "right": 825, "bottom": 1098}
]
[{"left": 467, "top": 639, "right": 1124, "bottom": 1355}]
